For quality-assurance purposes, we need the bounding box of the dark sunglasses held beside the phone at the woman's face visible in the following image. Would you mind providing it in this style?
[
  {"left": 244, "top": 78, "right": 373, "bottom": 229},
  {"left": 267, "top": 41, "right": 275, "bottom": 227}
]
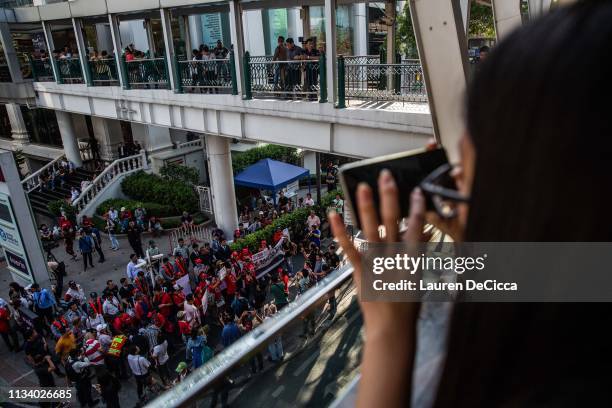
[{"left": 419, "top": 163, "right": 470, "bottom": 219}]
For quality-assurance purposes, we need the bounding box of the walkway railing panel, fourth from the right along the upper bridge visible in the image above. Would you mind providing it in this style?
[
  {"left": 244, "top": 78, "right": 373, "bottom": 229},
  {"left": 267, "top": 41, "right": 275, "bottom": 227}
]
[{"left": 122, "top": 56, "right": 169, "bottom": 89}]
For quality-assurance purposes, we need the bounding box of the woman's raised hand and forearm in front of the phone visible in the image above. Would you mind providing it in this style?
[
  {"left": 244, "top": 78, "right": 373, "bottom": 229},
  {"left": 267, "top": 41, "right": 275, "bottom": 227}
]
[{"left": 329, "top": 170, "right": 425, "bottom": 408}]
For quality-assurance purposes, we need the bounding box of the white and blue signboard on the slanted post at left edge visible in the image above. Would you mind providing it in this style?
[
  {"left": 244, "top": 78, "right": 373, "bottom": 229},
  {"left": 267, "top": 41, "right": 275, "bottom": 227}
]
[{"left": 0, "top": 193, "right": 33, "bottom": 280}]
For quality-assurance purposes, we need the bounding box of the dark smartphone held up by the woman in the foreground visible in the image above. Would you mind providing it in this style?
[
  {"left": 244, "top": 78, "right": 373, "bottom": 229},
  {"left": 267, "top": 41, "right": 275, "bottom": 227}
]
[{"left": 340, "top": 147, "right": 448, "bottom": 228}]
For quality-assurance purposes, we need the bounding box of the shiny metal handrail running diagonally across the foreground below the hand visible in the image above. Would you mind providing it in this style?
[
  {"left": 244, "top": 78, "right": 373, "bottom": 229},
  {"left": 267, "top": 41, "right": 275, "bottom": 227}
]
[{"left": 148, "top": 264, "right": 353, "bottom": 408}]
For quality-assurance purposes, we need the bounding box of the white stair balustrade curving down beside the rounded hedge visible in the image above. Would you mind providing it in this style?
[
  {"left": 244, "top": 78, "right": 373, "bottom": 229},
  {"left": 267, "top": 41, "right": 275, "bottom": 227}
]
[{"left": 72, "top": 150, "right": 149, "bottom": 214}]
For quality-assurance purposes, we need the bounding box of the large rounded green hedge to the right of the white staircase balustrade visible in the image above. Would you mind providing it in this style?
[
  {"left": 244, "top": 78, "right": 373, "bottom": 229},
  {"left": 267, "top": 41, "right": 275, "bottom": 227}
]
[{"left": 121, "top": 171, "right": 198, "bottom": 214}]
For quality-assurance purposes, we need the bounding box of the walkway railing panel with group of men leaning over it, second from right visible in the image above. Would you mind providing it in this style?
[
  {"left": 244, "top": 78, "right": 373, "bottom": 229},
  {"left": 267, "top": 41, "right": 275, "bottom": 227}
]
[{"left": 244, "top": 52, "right": 326, "bottom": 101}]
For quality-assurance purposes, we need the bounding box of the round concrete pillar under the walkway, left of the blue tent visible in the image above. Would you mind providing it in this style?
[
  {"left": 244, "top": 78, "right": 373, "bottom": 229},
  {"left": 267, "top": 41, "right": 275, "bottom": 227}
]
[{"left": 206, "top": 135, "right": 238, "bottom": 239}]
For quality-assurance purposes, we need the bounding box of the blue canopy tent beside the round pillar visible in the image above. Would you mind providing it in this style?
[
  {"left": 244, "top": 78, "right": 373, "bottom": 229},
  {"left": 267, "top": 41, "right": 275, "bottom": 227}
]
[{"left": 234, "top": 159, "right": 310, "bottom": 205}]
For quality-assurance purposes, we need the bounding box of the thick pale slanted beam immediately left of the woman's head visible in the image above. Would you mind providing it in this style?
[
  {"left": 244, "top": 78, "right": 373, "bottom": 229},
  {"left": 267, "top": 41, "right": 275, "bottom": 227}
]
[{"left": 410, "top": 0, "right": 467, "bottom": 162}]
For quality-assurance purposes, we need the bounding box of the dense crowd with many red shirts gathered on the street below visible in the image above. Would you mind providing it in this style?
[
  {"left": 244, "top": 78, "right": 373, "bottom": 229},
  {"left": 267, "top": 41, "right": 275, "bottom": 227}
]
[{"left": 0, "top": 197, "right": 340, "bottom": 407}]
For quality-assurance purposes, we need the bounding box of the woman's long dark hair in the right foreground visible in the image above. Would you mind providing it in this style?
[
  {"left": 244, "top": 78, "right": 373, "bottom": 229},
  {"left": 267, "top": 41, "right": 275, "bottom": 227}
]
[{"left": 436, "top": 1, "right": 612, "bottom": 408}]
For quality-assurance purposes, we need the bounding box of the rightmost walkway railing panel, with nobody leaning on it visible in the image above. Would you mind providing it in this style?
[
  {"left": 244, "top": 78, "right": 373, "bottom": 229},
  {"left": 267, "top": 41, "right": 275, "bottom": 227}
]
[{"left": 338, "top": 56, "right": 427, "bottom": 107}]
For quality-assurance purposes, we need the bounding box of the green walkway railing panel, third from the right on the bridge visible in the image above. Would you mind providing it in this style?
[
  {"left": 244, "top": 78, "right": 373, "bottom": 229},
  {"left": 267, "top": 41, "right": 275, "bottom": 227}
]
[{"left": 177, "top": 59, "right": 234, "bottom": 94}]
